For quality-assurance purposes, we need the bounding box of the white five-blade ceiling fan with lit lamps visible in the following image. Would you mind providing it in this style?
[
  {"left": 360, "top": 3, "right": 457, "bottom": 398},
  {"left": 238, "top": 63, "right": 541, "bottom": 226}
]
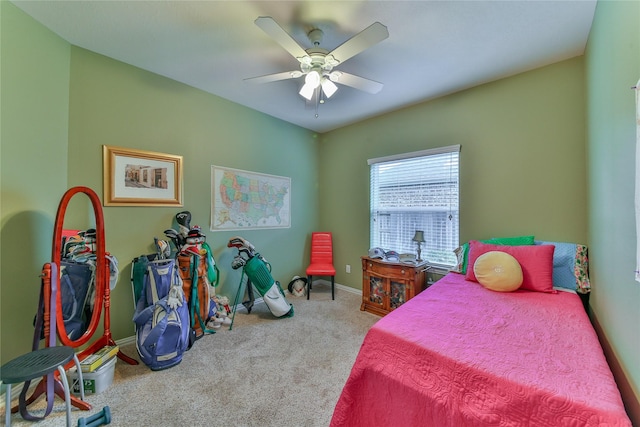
[{"left": 245, "top": 16, "right": 389, "bottom": 102}]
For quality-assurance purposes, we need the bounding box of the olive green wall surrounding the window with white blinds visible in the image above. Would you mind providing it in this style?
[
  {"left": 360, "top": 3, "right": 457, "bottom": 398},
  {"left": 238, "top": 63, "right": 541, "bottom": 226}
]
[{"left": 319, "top": 57, "right": 587, "bottom": 289}]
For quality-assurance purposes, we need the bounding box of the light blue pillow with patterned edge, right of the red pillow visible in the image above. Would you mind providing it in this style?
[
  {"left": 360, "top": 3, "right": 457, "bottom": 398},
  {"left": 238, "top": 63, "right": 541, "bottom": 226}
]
[{"left": 535, "top": 240, "right": 591, "bottom": 293}]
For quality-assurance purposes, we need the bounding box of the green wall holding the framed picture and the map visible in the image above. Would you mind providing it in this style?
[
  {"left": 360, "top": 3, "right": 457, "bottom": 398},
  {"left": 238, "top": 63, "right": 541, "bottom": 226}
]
[{"left": 69, "top": 47, "right": 318, "bottom": 344}]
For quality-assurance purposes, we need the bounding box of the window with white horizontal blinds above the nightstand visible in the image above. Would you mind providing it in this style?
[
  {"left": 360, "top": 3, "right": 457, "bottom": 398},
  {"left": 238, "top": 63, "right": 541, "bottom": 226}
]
[{"left": 368, "top": 145, "right": 460, "bottom": 266}]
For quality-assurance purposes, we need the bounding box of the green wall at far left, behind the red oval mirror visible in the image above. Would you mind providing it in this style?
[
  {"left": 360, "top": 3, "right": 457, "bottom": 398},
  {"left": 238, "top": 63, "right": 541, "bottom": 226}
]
[{"left": 0, "top": 1, "right": 70, "bottom": 363}]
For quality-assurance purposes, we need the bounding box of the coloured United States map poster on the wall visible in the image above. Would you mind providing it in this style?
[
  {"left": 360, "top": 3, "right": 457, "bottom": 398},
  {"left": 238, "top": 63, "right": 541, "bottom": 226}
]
[{"left": 211, "top": 166, "right": 291, "bottom": 231}]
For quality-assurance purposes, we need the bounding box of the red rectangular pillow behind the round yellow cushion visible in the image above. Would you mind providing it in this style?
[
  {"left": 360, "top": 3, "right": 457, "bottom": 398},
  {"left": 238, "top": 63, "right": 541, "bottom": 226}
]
[{"left": 465, "top": 240, "right": 555, "bottom": 292}]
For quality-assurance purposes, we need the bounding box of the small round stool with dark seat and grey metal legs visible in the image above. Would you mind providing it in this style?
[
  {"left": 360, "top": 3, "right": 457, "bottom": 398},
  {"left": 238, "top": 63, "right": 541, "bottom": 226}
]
[{"left": 0, "top": 346, "right": 84, "bottom": 427}]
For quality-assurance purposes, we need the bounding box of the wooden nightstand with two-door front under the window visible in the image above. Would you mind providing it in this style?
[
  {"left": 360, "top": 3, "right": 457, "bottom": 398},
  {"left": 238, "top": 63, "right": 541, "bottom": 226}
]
[{"left": 360, "top": 257, "right": 430, "bottom": 316}]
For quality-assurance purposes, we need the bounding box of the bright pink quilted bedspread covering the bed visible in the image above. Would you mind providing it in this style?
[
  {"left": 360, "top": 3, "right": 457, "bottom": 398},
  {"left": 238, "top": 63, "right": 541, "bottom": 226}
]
[{"left": 331, "top": 273, "right": 631, "bottom": 427}]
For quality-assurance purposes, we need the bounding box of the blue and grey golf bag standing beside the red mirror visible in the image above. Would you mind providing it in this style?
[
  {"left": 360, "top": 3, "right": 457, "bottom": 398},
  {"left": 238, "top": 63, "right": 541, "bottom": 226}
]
[{"left": 133, "top": 259, "right": 190, "bottom": 371}]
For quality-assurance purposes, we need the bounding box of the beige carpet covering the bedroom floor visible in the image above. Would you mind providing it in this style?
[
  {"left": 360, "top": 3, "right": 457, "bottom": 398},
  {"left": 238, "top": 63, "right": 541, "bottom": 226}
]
[{"left": 2, "top": 284, "right": 379, "bottom": 427}]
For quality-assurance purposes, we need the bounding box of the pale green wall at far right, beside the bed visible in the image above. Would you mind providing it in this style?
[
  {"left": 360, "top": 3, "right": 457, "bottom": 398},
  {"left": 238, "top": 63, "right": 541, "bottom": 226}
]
[{"left": 586, "top": 1, "right": 640, "bottom": 418}]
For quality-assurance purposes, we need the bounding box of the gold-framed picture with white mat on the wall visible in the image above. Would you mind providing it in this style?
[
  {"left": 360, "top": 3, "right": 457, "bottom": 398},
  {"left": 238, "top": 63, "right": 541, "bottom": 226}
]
[{"left": 102, "top": 145, "right": 183, "bottom": 206}]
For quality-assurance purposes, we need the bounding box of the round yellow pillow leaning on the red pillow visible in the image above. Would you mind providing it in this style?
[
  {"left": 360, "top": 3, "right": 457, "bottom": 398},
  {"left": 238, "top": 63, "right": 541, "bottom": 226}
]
[{"left": 473, "top": 251, "right": 522, "bottom": 292}]
